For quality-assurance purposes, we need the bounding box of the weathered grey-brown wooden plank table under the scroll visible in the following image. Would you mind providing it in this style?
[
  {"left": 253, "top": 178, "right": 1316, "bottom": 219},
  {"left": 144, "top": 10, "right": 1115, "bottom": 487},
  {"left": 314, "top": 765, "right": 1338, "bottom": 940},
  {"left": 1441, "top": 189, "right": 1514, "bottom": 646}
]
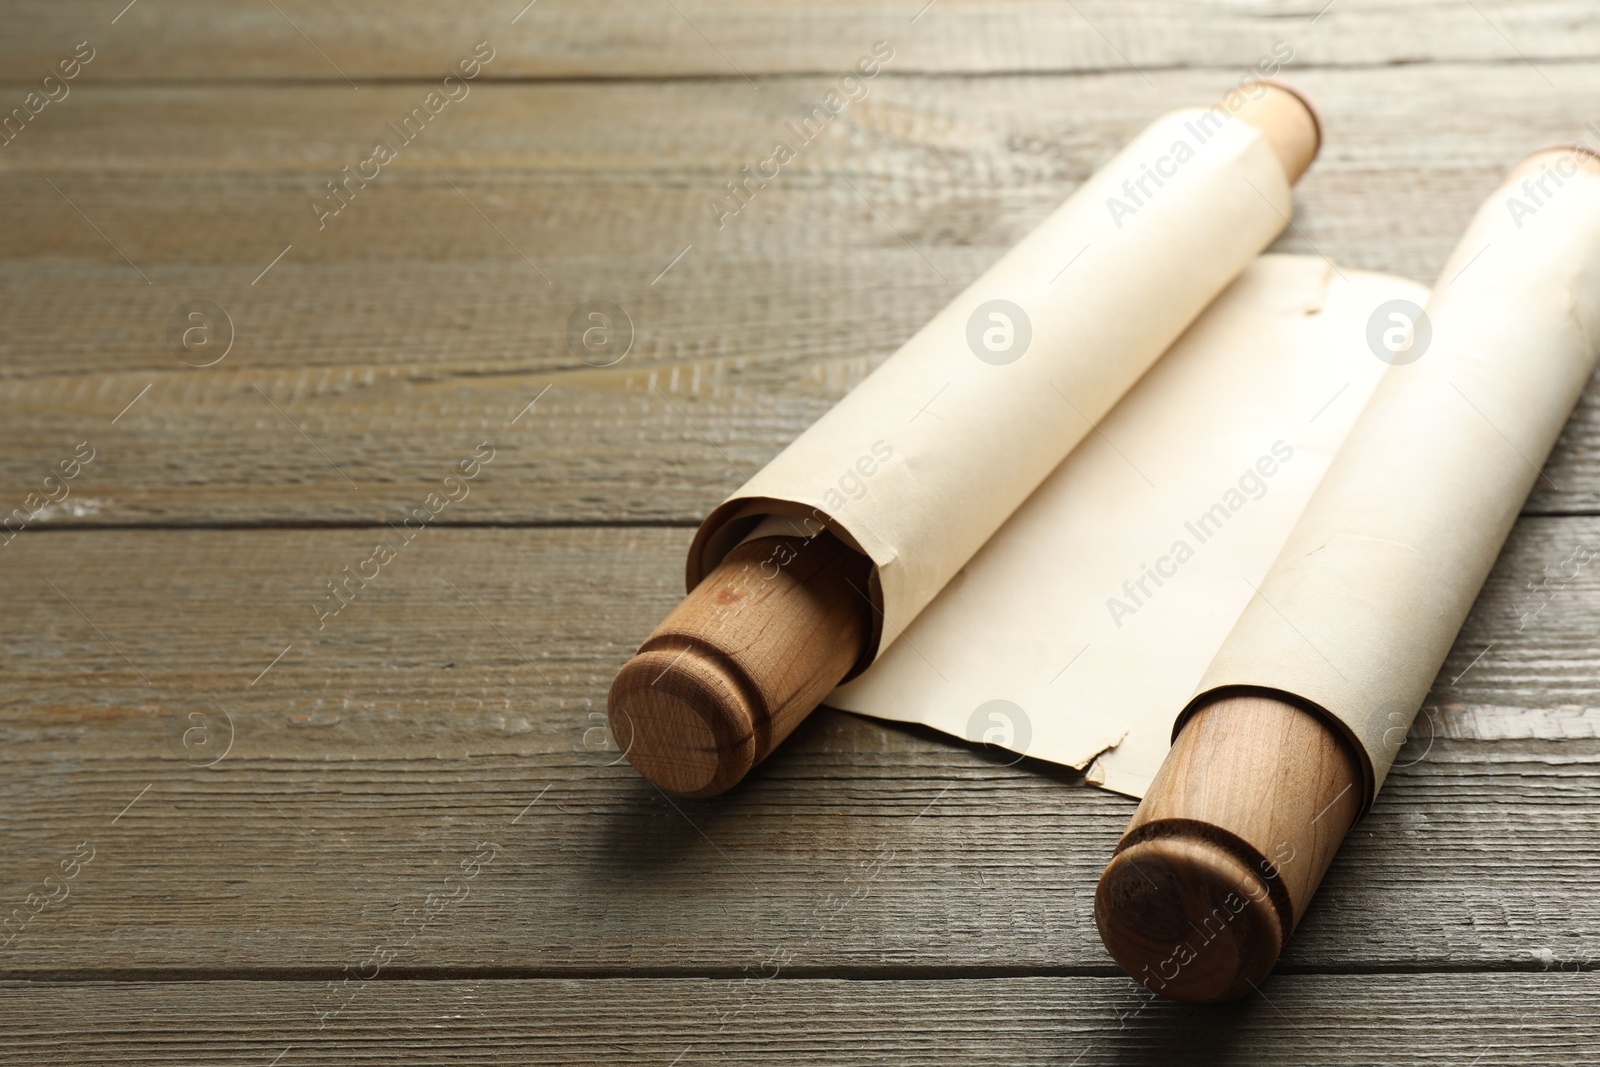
[{"left": 0, "top": 0, "right": 1600, "bottom": 1067}]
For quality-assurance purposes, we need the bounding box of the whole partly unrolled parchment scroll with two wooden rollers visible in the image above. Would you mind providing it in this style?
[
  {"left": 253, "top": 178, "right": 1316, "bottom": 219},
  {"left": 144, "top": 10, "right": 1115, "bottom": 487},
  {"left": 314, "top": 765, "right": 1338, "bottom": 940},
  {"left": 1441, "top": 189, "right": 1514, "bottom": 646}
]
[{"left": 610, "top": 86, "right": 1600, "bottom": 1000}]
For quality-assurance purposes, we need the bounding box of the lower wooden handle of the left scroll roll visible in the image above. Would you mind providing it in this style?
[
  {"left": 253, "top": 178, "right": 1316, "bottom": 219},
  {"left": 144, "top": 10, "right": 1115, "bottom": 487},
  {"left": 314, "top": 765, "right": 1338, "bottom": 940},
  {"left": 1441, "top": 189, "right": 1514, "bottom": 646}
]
[{"left": 610, "top": 531, "right": 872, "bottom": 797}]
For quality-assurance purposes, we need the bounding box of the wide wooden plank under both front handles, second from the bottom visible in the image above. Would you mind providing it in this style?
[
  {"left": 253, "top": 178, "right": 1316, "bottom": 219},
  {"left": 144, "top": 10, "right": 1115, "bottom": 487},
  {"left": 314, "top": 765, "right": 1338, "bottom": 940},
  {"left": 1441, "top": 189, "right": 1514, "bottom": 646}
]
[{"left": 0, "top": 518, "right": 1600, "bottom": 977}]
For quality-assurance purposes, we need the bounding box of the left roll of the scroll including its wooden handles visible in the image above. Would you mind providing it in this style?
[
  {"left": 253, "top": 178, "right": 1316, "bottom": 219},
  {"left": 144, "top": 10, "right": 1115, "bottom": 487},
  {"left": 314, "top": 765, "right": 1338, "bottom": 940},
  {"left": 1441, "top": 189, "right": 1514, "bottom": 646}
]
[{"left": 610, "top": 85, "right": 1317, "bottom": 795}]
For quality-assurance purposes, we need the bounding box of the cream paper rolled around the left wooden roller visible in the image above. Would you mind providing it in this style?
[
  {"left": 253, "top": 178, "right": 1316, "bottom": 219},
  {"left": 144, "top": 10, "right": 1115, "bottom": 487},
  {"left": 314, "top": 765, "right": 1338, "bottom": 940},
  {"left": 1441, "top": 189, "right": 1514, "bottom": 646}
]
[{"left": 688, "top": 109, "right": 1290, "bottom": 659}]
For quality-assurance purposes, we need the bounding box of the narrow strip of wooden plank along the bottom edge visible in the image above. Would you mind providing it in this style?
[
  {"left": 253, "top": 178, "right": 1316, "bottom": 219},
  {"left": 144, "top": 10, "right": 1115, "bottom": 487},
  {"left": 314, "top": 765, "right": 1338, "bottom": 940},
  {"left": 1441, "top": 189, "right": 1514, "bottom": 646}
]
[{"left": 0, "top": 973, "right": 1600, "bottom": 1067}]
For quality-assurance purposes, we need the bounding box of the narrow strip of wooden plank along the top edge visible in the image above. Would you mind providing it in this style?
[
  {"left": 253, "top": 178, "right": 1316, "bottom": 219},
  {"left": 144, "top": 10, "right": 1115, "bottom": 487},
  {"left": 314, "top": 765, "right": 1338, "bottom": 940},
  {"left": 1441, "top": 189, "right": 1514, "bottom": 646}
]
[{"left": 0, "top": 0, "right": 1600, "bottom": 88}]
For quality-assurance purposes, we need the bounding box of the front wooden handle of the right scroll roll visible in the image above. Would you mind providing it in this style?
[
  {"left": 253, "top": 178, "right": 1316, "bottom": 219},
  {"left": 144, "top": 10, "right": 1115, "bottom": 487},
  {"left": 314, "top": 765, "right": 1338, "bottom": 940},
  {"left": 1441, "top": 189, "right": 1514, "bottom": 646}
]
[{"left": 1094, "top": 696, "right": 1363, "bottom": 1001}]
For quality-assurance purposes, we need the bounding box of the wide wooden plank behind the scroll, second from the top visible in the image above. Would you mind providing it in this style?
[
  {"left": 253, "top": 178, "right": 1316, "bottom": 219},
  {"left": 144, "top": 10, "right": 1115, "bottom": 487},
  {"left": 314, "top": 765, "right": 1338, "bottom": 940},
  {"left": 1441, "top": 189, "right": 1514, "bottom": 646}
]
[{"left": 0, "top": 63, "right": 1600, "bottom": 525}]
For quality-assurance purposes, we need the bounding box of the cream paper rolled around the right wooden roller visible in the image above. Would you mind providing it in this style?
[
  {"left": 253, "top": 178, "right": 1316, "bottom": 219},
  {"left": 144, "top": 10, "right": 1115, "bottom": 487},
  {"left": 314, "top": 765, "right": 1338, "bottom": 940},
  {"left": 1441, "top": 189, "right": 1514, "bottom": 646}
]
[{"left": 1190, "top": 157, "right": 1600, "bottom": 803}]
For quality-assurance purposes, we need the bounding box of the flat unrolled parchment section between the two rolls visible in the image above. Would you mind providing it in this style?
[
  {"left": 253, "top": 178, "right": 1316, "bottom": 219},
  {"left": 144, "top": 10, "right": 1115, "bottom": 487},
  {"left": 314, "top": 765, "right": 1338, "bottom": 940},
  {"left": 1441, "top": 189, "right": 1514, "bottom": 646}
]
[{"left": 827, "top": 256, "right": 1427, "bottom": 795}]
